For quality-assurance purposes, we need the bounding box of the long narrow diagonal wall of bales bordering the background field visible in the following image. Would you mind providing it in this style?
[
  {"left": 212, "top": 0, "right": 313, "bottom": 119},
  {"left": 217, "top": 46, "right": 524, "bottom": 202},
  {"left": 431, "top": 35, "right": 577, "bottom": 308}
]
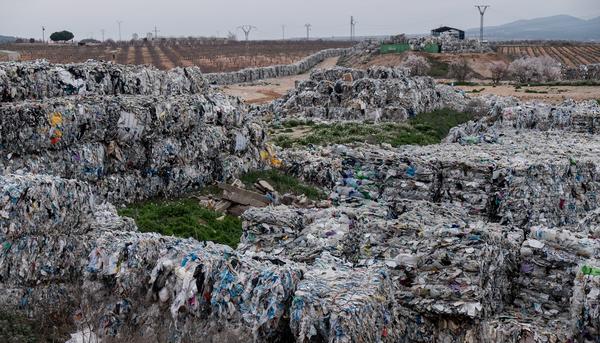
[{"left": 204, "top": 49, "right": 350, "bottom": 85}]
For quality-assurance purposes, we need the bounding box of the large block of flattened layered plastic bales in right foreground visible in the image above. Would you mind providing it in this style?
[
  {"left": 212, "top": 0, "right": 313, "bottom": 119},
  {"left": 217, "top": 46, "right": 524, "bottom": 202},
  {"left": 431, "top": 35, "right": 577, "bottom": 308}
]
[{"left": 356, "top": 200, "right": 523, "bottom": 319}]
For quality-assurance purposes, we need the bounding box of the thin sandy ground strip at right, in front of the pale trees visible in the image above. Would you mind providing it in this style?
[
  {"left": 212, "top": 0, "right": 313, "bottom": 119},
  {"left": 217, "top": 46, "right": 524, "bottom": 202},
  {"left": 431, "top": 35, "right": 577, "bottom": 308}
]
[{"left": 457, "top": 85, "right": 600, "bottom": 104}]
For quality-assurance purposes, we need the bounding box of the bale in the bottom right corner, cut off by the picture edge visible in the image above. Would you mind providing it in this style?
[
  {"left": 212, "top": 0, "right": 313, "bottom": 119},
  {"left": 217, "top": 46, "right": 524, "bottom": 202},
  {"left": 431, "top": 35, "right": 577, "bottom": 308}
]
[{"left": 570, "top": 262, "right": 600, "bottom": 342}]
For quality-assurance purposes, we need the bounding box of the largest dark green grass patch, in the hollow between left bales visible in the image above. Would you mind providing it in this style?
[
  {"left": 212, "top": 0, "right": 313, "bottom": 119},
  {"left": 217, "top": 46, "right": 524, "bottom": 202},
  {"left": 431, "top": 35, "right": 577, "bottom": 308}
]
[{"left": 119, "top": 198, "right": 242, "bottom": 248}]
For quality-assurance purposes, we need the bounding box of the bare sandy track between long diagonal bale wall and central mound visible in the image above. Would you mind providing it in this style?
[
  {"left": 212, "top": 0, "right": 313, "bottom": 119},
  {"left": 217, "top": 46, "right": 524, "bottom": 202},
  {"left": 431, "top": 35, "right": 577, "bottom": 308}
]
[{"left": 221, "top": 57, "right": 339, "bottom": 104}]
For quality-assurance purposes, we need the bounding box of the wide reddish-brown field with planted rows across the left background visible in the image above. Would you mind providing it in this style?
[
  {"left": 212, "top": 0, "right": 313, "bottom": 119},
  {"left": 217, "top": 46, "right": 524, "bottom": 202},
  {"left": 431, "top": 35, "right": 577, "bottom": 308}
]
[{"left": 0, "top": 39, "right": 352, "bottom": 73}]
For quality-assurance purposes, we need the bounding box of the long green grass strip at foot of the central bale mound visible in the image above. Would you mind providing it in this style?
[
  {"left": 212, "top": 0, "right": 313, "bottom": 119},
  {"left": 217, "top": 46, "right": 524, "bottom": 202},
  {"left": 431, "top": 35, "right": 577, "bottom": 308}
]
[{"left": 274, "top": 110, "right": 473, "bottom": 148}]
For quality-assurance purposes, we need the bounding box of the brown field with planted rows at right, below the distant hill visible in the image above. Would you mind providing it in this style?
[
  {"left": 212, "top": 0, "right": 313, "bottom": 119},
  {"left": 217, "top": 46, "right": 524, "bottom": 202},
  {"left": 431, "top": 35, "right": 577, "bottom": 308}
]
[{"left": 497, "top": 44, "right": 600, "bottom": 67}]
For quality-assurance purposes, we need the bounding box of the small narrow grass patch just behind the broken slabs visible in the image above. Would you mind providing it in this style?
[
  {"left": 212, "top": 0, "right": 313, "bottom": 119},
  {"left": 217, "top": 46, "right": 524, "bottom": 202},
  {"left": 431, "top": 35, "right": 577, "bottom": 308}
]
[{"left": 240, "top": 169, "right": 326, "bottom": 200}]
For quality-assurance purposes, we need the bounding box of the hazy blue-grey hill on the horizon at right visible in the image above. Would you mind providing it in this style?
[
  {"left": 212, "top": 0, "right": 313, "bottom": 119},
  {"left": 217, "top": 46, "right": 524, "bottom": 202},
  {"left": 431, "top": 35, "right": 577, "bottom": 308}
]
[{"left": 466, "top": 15, "right": 600, "bottom": 41}]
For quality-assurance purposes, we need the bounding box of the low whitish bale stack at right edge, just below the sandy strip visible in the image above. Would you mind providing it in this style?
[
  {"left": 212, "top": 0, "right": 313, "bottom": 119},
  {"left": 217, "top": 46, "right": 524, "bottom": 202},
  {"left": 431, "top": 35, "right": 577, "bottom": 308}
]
[{"left": 445, "top": 98, "right": 600, "bottom": 144}]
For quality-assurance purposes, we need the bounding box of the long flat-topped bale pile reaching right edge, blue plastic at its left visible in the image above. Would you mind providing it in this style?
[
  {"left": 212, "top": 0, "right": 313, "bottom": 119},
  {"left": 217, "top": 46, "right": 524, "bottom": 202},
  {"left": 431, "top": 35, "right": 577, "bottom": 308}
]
[{"left": 280, "top": 127, "right": 600, "bottom": 230}]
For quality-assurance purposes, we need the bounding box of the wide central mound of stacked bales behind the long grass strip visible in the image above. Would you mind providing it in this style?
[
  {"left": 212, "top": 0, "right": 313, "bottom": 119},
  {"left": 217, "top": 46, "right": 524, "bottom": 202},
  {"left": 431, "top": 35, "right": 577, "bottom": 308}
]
[{"left": 269, "top": 67, "right": 467, "bottom": 121}]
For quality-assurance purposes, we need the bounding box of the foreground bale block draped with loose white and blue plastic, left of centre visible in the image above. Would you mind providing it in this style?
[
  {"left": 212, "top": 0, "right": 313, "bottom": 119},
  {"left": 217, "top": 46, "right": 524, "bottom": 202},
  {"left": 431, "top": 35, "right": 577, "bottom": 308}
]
[{"left": 84, "top": 232, "right": 303, "bottom": 341}]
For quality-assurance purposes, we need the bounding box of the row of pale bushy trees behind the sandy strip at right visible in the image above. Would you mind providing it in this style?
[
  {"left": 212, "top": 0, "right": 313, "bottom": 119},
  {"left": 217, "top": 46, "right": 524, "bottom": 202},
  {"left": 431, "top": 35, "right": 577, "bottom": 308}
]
[{"left": 401, "top": 55, "right": 561, "bottom": 84}]
